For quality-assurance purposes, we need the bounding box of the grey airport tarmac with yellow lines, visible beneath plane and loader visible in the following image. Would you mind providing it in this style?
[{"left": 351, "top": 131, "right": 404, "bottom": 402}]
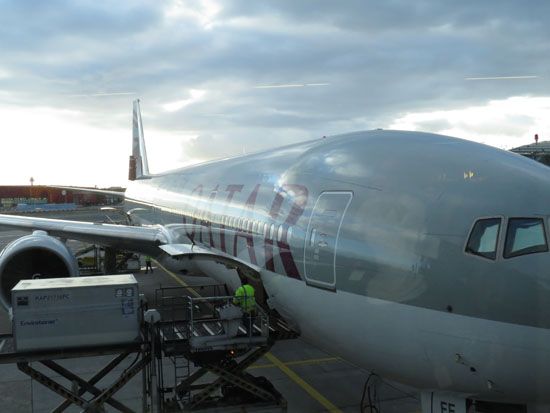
[{"left": 0, "top": 208, "right": 420, "bottom": 413}]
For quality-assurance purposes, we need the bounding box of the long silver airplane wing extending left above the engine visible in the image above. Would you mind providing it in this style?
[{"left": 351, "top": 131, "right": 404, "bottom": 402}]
[{"left": 0, "top": 215, "right": 170, "bottom": 253}]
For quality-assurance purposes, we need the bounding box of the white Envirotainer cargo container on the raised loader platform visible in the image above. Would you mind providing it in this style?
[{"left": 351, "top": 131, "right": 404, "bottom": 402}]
[{"left": 11, "top": 274, "right": 140, "bottom": 351}]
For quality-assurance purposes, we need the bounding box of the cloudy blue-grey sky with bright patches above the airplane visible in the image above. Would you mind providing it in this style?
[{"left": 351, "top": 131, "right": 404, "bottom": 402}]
[{"left": 0, "top": 0, "right": 550, "bottom": 186}]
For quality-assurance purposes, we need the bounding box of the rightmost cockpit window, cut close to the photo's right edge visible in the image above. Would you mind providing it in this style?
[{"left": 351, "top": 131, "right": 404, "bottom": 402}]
[{"left": 504, "top": 218, "right": 548, "bottom": 258}]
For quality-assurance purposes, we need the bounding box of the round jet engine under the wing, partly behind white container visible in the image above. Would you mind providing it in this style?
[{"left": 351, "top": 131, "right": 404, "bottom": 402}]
[{"left": 0, "top": 231, "right": 78, "bottom": 310}]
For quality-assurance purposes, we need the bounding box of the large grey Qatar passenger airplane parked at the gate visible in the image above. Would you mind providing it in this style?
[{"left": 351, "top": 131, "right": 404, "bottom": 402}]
[{"left": 0, "top": 100, "right": 550, "bottom": 413}]
